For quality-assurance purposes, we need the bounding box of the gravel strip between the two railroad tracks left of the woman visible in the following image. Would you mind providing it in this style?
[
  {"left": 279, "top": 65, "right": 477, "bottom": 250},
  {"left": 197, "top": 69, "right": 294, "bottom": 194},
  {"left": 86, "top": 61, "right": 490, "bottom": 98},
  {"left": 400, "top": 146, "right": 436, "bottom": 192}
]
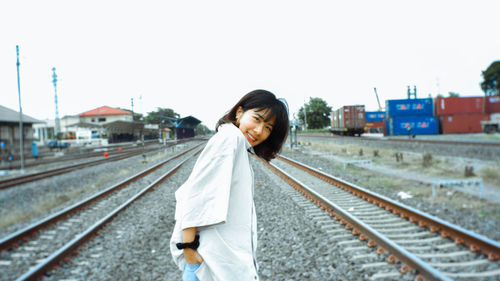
[{"left": 0, "top": 141, "right": 203, "bottom": 237}]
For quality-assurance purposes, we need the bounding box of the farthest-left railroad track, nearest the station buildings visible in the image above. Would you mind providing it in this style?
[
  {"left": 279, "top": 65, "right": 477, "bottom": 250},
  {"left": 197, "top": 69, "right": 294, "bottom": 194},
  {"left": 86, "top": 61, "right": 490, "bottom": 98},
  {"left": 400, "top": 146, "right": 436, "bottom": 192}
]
[{"left": 0, "top": 139, "right": 193, "bottom": 189}]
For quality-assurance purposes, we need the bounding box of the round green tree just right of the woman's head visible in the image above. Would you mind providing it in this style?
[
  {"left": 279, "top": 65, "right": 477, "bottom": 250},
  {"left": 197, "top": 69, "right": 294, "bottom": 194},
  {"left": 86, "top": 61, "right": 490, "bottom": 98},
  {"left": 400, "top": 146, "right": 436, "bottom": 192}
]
[{"left": 298, "top": 98, "right": 332, "bottom": 129}]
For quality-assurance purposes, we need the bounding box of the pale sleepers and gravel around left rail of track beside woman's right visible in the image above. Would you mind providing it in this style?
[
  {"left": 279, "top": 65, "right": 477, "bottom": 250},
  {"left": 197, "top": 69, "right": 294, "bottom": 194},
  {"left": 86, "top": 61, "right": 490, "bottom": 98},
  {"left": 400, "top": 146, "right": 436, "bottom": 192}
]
[{"left": 273, "top": 156, "right": 500, "bottom": 280}]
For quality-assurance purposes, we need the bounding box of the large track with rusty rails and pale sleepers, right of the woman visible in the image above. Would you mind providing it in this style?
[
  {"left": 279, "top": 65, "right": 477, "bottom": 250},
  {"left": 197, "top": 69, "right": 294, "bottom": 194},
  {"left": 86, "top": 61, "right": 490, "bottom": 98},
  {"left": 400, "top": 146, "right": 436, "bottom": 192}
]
[{"left": 268, "top": 154, "right": 500, "bottom": 280}]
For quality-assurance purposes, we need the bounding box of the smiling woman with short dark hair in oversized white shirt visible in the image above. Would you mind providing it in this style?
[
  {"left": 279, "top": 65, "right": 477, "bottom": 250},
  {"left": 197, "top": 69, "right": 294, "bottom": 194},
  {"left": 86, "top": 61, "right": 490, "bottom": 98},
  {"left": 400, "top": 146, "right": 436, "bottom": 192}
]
[{"left": 170, "top": 90, "right": 289, "bottom": 281}]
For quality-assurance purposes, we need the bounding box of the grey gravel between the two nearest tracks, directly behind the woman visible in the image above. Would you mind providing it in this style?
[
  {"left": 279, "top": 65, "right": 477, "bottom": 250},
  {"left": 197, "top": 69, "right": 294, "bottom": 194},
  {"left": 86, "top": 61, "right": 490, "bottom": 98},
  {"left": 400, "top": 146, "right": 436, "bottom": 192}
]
[{"left": 44, "top": 156, "right": 366, "bottom": 281}]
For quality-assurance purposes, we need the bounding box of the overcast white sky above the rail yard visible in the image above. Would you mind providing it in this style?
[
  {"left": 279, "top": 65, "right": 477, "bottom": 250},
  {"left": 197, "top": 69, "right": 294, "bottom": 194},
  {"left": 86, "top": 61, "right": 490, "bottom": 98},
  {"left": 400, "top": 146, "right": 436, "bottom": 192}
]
[{"left": 0, "top": 0, "right": 500, "bottom": 129}]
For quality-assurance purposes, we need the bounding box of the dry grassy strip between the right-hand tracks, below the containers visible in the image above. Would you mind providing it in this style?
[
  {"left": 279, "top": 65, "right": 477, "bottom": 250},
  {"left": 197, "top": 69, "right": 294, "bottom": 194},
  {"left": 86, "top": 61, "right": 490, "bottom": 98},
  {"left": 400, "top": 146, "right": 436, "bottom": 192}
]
[{"left": 286, "top": 142, "right": 500, "bottom": 222}]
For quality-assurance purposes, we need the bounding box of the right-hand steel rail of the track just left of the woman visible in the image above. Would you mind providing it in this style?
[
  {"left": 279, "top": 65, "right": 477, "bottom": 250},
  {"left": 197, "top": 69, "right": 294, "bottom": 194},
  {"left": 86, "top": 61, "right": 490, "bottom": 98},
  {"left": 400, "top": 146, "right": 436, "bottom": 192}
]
[{"left": 16, "top": 149, "right": 201, "bottom": 281}]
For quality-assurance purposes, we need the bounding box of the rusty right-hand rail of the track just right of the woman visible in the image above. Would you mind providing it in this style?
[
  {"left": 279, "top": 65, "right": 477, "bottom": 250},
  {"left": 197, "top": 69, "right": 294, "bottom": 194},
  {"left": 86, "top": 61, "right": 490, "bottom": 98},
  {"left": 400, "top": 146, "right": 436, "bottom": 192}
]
[{"left": 279, "top": 155, "right": 500, "bottom": 261}]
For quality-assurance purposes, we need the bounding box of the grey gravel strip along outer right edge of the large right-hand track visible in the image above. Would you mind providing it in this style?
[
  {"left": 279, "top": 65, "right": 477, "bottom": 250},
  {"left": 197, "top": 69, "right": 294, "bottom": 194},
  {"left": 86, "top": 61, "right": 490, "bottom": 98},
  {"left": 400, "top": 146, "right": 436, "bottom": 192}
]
[{"left": 283, "top": 150, "right": 500, "bottom": 241}]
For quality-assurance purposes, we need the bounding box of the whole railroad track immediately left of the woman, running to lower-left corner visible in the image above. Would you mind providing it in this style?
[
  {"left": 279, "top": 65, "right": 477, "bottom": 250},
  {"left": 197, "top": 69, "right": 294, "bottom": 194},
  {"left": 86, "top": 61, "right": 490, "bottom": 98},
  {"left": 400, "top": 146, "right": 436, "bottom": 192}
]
[{"left": 0, "top": 144, "right": 201, "bottom": 280}]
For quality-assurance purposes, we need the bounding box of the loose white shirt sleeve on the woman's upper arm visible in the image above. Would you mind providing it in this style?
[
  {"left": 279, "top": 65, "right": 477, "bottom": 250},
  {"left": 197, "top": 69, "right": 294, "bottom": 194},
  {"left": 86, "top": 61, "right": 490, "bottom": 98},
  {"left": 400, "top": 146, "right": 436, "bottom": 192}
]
[{"left": 175, "top": 135, "right": 237, "bottom": 229}]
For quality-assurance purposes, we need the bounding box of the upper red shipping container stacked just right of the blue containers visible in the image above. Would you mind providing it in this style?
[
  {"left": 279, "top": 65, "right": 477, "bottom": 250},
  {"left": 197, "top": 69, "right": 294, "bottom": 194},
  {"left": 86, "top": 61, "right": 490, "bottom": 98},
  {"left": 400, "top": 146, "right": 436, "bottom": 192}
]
[{"left": 434, "top": 97, "right": 484, "bottom": 116}]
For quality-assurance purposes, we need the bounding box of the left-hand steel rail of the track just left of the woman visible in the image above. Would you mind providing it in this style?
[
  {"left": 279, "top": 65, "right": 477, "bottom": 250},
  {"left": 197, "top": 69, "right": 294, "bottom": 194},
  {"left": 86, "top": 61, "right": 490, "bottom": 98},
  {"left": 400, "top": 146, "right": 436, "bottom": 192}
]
[{"left": 0, "top": 144, "right": 202, "bottom": 251}]
